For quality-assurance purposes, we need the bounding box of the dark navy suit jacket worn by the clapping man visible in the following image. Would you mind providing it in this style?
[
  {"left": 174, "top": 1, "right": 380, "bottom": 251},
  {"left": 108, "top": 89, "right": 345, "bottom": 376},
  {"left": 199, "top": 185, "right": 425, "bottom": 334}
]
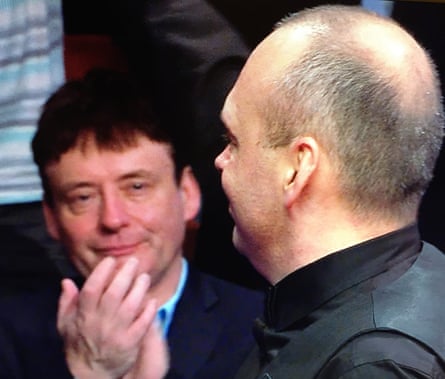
[{"left": 0, "top": 267, "right": 262, "bottom": 379}]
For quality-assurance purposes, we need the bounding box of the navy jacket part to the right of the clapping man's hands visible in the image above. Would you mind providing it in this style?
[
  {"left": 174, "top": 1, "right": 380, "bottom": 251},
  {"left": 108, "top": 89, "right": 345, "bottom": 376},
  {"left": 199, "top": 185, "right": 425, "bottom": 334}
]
[{"left": 168, "top": 269, "right": 263, "bottom": 379}]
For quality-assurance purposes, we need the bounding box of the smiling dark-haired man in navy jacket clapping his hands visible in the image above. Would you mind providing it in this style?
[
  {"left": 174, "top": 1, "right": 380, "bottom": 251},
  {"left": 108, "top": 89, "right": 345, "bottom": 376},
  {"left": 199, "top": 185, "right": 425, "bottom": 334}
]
[{"left": 0, "top": 71, "right": 262, "bottom": 379}]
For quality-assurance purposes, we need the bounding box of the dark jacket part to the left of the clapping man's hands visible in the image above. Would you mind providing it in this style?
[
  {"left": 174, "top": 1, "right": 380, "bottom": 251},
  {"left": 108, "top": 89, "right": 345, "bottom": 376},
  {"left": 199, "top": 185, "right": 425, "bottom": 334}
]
[{"left": 0, "top": 283, "right": 71, "bottom": 379}]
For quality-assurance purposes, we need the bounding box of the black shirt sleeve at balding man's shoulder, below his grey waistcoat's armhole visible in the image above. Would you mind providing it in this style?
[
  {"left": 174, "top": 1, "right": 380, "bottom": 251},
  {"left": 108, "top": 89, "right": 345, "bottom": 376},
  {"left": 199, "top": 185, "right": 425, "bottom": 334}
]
[{"left": 317, "top": 330, "right": 445, "bottom": 379}]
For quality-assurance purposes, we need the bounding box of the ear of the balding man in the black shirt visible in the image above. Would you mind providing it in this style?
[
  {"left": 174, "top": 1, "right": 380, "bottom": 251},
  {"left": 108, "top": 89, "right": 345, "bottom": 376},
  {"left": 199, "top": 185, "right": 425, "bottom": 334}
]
[{"left": 284, "top": 137, "right": 320, "bottom": 208}]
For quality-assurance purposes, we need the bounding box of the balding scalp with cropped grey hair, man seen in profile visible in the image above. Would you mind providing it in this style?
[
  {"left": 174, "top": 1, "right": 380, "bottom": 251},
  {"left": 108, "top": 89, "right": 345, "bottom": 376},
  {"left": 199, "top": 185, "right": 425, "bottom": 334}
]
[{"left": 246, "top": 6, "right": 443, "bottom": 220}]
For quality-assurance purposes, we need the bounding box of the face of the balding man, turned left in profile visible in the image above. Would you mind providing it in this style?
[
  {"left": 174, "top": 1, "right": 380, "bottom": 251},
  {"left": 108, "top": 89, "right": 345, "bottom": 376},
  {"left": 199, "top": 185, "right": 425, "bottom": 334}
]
[{"left": 215, "top": 49, "right": 283, "bottom": 273}]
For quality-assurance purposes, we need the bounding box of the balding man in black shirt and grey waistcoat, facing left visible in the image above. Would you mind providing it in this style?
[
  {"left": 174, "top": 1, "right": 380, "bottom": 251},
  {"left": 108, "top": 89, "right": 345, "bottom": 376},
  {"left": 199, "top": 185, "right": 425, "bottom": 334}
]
[{"left": 215, "top": 6, "right": 445, "bottom": 379}]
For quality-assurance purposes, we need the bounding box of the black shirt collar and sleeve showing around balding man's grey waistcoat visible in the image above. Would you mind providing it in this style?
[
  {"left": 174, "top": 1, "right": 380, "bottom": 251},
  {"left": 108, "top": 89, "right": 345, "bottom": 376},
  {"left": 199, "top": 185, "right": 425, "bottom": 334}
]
[{"left": 241, "top": 224, "right": 445, "bottom": 379}]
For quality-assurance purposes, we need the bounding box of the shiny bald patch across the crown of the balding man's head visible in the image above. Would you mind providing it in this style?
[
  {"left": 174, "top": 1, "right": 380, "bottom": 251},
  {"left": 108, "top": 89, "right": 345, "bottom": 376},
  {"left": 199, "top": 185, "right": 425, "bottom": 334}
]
[{"left": 277, "top": 6, "right": 436, "bottom": 111}]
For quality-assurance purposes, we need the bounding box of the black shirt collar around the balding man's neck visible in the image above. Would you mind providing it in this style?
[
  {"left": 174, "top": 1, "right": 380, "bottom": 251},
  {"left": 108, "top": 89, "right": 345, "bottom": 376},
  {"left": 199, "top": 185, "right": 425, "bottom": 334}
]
[{"left": 265, "top": 224, "right": 421, "bottom": 330}]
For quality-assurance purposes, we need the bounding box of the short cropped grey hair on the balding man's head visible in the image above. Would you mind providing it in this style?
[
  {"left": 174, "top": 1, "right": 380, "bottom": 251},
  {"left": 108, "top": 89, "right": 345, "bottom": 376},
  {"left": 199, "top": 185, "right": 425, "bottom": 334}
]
[{"left": 263, "top": 6, "right": 444, "bottom": 217}]
